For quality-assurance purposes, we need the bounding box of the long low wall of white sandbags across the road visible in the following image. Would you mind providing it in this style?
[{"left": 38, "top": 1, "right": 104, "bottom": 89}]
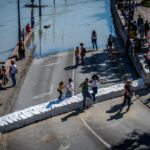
[{"left": 0, "top": 79, "right": 144, "bottom": 133}]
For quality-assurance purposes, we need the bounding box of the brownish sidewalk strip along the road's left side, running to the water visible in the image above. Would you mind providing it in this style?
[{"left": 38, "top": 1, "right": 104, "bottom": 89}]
[{"left": 0, "top": 30, "right": 34, "bottom": 116}]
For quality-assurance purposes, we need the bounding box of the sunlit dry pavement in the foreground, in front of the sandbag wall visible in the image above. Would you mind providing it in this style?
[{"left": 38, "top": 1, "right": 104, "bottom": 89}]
[{"left": 1, "top": 97, "right": 150, "bottom": 150}]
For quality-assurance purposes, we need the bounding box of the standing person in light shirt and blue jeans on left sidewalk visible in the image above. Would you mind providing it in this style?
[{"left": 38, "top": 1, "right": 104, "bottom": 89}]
[{"left": 9, "top": 60, "right": 18, "bottom": 86}]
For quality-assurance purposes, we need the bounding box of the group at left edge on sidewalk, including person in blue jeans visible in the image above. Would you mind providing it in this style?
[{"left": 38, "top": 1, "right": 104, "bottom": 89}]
[{"left": 0, "top": 60, "right": 18, "bottom": 90}]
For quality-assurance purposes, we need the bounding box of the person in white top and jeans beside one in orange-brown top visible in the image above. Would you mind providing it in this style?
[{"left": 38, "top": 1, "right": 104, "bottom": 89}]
[{"left": 66, "top": 78, "right": 74, "bottom": 98}]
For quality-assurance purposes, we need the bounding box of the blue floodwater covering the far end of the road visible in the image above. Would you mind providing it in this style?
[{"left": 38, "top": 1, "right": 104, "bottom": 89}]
[{"left": 0, "top": 0, "right": 115, "bottom": 61}]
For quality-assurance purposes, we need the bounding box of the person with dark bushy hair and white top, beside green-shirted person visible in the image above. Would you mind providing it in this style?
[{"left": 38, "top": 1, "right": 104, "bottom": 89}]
[{"left": 90, "top": 74, "right": 100, "bottom": 102}]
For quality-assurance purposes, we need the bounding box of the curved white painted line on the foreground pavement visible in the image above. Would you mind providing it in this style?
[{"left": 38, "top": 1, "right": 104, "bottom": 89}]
[{"left": 79, "top": 115, "right": 111, "bottom": 149}]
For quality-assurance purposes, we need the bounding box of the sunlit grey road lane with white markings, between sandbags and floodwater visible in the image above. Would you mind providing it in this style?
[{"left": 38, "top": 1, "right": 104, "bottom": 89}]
[{"left": 12, "top": 52, "right": 73, "bottom": 111}]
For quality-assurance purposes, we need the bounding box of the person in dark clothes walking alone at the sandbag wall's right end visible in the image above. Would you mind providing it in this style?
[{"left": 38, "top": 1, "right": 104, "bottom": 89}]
[{"left": 122, "top": 80, "right": 133, "bottom": 110}]
